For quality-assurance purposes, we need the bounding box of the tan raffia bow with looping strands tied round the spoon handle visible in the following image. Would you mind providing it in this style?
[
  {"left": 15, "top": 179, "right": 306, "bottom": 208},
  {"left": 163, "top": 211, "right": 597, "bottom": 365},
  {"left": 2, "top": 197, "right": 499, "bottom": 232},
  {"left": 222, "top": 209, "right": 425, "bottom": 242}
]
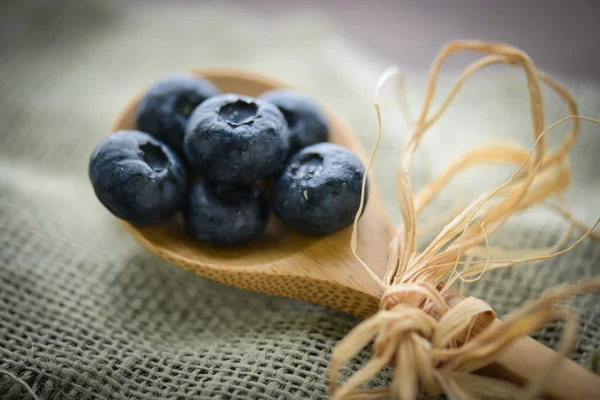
[{"left": 330, "top": 41, "right": 600, "bottom": 400}]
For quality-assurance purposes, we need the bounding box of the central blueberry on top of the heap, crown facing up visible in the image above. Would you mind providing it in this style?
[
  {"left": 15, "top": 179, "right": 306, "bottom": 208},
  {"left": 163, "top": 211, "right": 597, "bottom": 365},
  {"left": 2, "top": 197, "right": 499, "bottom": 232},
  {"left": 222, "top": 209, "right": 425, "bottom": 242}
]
[{"left": 184, "top": 94, "right": 289, "bottom": 183}]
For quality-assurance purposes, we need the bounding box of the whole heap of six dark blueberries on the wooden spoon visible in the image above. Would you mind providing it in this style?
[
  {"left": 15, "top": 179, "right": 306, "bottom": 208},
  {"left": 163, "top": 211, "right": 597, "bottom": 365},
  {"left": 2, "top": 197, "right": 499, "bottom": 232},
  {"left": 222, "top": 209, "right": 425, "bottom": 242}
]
[{"left": 89, "top": 75, "right": 364, "bottom": 247}]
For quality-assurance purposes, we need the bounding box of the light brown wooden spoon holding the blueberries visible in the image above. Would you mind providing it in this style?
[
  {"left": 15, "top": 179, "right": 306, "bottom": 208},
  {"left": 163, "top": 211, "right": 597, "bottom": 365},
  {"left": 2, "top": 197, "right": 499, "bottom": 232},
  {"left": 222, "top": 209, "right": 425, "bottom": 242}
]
[{"left": 111, "top": 69, "right": 600, "bottom": 399}]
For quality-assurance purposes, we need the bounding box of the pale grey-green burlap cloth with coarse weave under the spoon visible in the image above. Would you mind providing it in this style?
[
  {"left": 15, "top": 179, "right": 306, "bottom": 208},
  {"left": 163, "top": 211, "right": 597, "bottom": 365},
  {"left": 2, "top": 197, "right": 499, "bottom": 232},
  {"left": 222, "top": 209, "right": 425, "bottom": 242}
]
[{"left": 0, "top": 0, "right": 600, "bottom": 399}]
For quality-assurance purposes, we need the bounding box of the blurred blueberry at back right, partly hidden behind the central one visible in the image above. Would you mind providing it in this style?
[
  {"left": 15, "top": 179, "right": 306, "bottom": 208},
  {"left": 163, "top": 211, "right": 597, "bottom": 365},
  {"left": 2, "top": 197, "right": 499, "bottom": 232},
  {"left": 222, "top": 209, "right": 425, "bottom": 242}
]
[{"left": 260, "top": 89, "right": 329, "bottom": 154}]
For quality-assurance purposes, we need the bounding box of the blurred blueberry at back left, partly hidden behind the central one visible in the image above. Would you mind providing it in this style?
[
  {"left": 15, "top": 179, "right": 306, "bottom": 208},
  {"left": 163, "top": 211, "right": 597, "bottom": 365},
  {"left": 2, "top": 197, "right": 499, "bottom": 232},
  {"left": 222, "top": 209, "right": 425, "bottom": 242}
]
[{"left": 136, "top": 75, "right": 219, "bottom": 157}]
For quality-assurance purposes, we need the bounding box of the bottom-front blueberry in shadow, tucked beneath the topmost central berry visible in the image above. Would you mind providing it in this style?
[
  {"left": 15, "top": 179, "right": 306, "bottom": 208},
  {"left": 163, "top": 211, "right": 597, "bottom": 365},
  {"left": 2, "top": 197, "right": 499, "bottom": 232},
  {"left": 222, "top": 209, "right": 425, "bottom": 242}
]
[{"left": 184, "top": 180, "right": 269, "bottom": 247}]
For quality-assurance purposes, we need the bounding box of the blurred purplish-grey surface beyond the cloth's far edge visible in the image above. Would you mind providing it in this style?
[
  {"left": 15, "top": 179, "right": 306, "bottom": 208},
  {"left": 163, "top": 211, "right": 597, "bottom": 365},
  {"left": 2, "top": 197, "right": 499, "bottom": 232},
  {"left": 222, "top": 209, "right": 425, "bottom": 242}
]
[{"left": 0, "top": 0, "right": 600, "bottom": 80}]
